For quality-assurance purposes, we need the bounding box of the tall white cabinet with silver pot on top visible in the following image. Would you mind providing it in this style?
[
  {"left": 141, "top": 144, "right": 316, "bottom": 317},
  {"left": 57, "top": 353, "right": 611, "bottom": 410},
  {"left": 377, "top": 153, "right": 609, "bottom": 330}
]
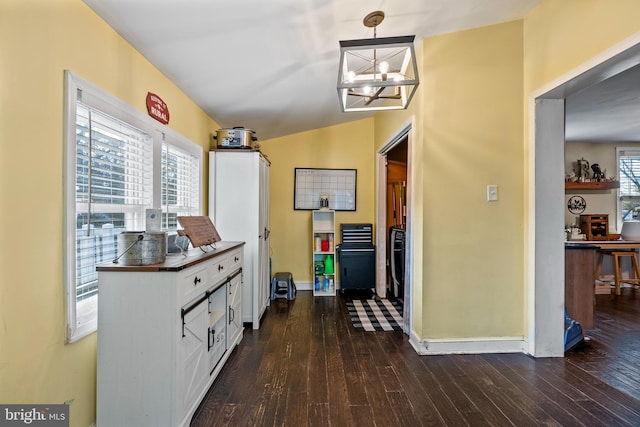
[{"left": 209, "top": 150, "right": 271, "bottom": 329}]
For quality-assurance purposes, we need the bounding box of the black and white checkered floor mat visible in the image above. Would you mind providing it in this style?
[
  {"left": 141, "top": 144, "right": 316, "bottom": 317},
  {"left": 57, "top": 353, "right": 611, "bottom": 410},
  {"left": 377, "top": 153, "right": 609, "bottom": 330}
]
[{"left": 347, "top": 299, "right": 402, "bottom": 331}]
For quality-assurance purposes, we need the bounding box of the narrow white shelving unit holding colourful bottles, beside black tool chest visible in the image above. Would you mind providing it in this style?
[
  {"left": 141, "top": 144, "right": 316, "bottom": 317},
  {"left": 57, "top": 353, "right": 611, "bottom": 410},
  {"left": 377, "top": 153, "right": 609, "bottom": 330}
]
[{"left": 311, "top": 209, "right": 336, "bottom": 296}]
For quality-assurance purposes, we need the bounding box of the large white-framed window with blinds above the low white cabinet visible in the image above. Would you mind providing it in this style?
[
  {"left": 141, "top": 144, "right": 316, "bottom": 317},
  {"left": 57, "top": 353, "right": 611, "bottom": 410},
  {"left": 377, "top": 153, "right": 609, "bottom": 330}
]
[{"left": 65, "top": 72, "right": 202, "bottom": 342}]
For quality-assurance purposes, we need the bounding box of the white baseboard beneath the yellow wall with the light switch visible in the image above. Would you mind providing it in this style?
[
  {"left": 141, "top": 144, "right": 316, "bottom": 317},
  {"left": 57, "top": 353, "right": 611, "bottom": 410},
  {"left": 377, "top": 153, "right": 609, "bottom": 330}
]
[{"left": 409, "top": 331, "right": 527, "bottom": 356}]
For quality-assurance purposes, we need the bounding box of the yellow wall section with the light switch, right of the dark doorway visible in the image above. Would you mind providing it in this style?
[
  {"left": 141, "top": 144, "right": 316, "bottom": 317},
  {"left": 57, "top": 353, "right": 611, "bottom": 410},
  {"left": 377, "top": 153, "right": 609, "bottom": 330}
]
[{"left": 421, "top": 21, "right": 524, "bottom": 339}]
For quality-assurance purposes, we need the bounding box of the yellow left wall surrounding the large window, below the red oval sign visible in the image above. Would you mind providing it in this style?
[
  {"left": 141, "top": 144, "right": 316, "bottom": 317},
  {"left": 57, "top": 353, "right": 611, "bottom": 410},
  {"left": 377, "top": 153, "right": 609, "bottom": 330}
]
[{"left": 0, "top": 0, "right": 218, "bottom": 427}]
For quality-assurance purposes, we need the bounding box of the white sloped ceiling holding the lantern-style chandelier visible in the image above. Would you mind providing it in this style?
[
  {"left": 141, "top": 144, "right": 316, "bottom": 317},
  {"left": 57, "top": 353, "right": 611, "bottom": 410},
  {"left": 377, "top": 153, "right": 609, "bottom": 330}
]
[{"left": 79, "top": 0, "right": 540, "bottom": 140}]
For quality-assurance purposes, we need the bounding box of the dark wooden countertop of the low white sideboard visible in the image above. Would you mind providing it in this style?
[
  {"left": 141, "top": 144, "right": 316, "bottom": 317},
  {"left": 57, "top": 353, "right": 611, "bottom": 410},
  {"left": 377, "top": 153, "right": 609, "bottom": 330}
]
[{"left": 96, "top": 241, "right": 245, "bottom": 272}]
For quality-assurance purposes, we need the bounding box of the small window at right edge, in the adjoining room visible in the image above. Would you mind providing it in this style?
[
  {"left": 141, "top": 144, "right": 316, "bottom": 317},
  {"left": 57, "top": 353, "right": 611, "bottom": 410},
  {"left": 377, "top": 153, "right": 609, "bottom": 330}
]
[{"left": 616, "top": 147, "right": 640, "bottom": 221}]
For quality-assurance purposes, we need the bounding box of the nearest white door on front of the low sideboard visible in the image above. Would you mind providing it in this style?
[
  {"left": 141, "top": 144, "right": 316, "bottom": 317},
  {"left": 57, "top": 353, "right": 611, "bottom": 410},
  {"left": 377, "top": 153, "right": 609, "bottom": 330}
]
[{"left": 178, "top": 300, "right": 209, "bottom": 419}]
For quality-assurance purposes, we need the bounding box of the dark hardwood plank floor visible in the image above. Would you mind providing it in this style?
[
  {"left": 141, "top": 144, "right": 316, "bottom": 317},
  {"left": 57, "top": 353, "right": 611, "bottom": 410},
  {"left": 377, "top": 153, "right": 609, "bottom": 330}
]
[{"left": 191, "top": 288, "right": 640, "bottom": 427}]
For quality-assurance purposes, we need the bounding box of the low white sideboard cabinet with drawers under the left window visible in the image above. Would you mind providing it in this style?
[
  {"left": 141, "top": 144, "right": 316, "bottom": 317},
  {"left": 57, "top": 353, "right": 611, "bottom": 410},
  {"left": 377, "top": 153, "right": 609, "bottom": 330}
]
[{"left": 96, "top": 241, "right": 243, "bottom": 427}]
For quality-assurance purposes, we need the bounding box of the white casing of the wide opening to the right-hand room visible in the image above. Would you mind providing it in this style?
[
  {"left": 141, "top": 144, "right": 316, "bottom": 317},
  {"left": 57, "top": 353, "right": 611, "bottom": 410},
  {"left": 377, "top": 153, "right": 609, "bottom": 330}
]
[{"left": 527, "top": 33, "right": 640, "bottom": 357}]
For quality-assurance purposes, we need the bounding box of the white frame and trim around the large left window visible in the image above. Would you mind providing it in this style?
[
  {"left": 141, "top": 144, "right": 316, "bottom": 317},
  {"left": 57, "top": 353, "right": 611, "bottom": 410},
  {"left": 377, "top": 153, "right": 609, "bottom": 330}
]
[{"left": 63, "top": 70, "right": 204, "bottom": 344}]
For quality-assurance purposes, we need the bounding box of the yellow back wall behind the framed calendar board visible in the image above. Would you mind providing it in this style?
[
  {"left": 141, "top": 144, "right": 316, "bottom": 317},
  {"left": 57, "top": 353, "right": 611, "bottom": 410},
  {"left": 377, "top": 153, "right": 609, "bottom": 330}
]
[{"left": 261, "top": 119, "right": 375, "bottom": 283}]
